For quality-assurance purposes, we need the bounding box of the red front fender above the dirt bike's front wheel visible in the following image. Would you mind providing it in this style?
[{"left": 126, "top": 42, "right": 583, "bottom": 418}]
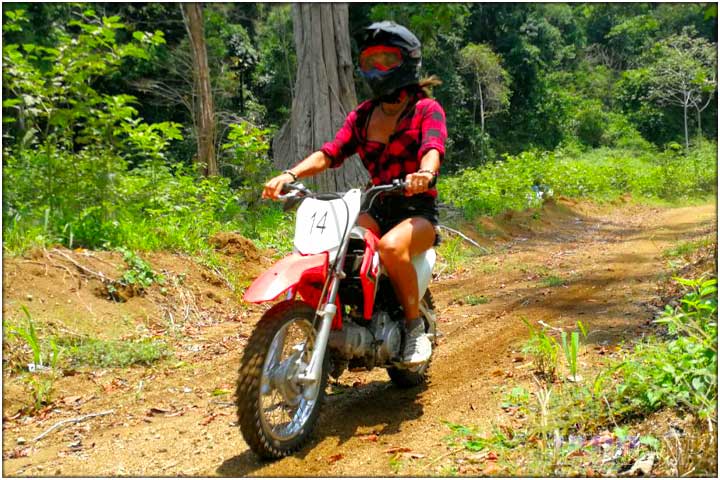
[{"left": 243, "top": 252, "right": 328, "bottom": 303}]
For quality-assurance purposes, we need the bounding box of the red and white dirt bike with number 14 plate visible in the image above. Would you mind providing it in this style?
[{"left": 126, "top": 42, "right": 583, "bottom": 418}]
[{"left": 236, "top": 181, "right": 437, "bottom": 459}]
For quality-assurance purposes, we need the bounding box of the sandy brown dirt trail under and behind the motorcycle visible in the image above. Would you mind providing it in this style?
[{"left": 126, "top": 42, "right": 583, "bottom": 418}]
[{"left": 3, "top": 202, "right": 717, "bottom": 477}]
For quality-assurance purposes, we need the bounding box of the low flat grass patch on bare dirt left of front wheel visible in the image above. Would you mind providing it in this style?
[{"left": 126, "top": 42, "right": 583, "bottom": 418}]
[{"left": 58, "top": 338, "right": 171, "bottom": 368}]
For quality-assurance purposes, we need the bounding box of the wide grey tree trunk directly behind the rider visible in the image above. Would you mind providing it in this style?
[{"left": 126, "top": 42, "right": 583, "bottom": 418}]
[{"left": 273, "top": 3, "right": 369, "bottom": 191}]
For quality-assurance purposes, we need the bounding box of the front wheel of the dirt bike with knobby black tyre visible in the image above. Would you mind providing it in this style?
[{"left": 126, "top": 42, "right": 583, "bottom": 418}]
[{"left": 236, "top": 300, "right": 329, "bottom": 459}]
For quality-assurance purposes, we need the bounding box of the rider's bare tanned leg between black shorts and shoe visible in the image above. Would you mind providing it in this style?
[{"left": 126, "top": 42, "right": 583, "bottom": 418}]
[{"left": 379, "top": 217, "right": 435, "bottom": 321}]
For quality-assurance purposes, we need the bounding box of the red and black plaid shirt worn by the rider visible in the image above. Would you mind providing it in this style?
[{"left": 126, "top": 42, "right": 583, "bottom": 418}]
[{"left": 320, "top": 91, "right": 447, "bottom": 197}]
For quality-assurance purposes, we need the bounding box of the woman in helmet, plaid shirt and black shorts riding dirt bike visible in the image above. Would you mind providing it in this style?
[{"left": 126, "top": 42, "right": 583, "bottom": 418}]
[{"left": 263, "top": 21, "right": 447, "bottom": 365}]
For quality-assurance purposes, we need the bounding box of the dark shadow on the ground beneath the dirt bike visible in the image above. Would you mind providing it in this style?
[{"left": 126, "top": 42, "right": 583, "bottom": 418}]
[{"left": 217, "top": 379, "right": 428, "bottom": 477}]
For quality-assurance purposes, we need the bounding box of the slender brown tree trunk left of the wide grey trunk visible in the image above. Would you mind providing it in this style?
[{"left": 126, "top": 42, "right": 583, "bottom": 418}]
[{"left": 181, "top": 3, "right": 218, "bottom": 176}]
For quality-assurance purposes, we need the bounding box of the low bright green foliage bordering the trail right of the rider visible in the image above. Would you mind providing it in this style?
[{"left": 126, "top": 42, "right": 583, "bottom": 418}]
[{"left": 438, "top": 144, "right": 717, "bottom": 218}]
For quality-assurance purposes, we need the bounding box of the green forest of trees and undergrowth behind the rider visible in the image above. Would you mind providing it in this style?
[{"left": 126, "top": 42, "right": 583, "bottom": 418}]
[{"left": 3, "top": 2, "right": 717, "bottom": 254}]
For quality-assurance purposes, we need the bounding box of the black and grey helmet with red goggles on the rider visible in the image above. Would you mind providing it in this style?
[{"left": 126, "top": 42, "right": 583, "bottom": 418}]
[{"left": 359, "top": 21, "right": 422, "bottom": 101}]
